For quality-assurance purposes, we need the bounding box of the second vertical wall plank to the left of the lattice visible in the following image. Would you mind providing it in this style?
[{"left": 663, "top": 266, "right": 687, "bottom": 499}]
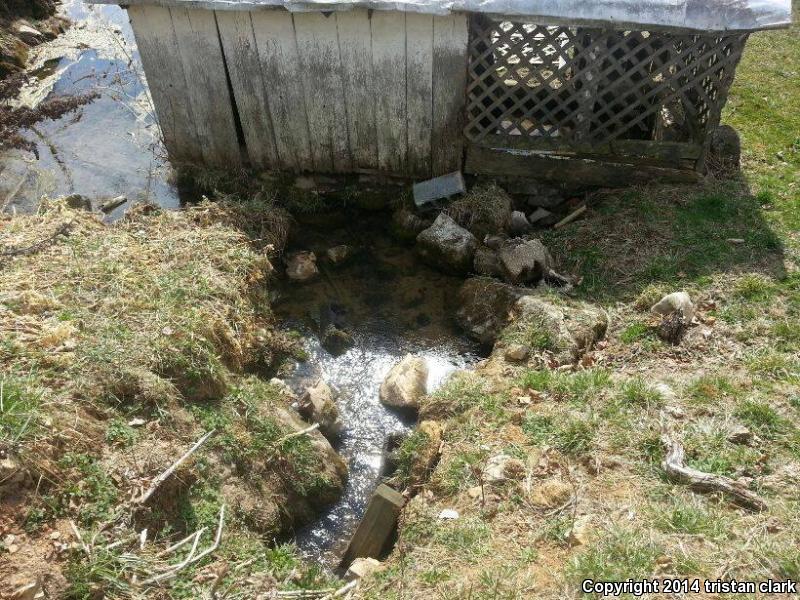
[{"left": 406, "top": 13, "right": 433, "bottom": 179}]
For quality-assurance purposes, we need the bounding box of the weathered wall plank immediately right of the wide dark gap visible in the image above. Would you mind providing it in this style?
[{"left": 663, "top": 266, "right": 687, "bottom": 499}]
[{"left": 217, "top": 10, "right": 279, "bottom": 169}]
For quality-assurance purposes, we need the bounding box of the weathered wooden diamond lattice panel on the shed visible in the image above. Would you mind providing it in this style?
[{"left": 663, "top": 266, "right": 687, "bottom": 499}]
[{"left": 465, "top": 16, "right": 747, "bottom": 148}]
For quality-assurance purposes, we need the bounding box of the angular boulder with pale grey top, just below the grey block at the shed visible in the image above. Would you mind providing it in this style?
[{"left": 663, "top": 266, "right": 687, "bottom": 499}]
[{"left": 417, "top": 213, "right": 478, "bottom": 274}]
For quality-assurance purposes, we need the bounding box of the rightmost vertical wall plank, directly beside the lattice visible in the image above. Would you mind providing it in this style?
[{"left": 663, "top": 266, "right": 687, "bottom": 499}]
[{"left": 431, "top": 14, "right": 469, "bottom": 176}]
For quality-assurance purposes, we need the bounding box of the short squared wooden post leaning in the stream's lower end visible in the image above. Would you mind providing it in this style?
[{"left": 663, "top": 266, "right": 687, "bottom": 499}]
[{"left": 341, "top": 484, "right": 405, "bottom": 568}]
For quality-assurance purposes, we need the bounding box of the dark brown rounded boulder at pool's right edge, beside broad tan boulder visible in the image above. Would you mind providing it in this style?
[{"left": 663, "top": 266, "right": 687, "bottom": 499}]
[{"left": 456, "top": 277, "right": 533, "bottom": 344}]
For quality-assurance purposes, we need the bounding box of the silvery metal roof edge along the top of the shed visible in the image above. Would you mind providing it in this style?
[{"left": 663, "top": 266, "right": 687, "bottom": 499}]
[{"left": 89, "top": 0, "right": 791, "bottom": 31}]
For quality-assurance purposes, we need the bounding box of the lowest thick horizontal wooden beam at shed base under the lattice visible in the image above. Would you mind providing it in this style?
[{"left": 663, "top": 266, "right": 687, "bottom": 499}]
[{"left": 464, "top": 144, "right": 700, "bottom": 187}]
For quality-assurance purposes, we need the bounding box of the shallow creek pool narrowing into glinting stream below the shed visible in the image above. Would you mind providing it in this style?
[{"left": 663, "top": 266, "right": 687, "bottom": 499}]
[{"left": 275, "top": 214, "right": 477, "bottom": 566}]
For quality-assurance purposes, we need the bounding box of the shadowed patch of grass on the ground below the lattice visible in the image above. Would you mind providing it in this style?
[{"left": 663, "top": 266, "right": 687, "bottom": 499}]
[{"left": 542, "top": 180, "right": 785, "bottom": 301}]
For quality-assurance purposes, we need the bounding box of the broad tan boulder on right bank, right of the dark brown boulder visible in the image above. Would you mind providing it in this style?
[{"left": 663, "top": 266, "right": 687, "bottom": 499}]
[{"left": 506, "top": 295, "right": 608, "bottom": 365}]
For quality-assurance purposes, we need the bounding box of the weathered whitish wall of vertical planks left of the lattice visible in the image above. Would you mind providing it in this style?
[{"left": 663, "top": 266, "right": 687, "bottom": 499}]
[{"left": 128, "top": 5, "right": 468, "bottom": 177}]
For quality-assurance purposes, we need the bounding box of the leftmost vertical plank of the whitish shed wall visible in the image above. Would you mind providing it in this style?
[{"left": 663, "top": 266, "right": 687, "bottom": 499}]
[{"left": 128, "top": 5, "right": 202, "bottom": 162}]
